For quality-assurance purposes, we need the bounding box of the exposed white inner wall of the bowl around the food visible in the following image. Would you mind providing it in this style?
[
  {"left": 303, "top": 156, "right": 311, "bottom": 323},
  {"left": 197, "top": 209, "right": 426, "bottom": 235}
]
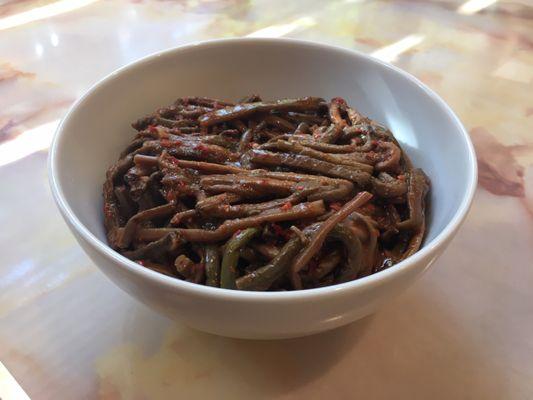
[{"left": 52, "top": 40, "right": 475, "bottom": 268}]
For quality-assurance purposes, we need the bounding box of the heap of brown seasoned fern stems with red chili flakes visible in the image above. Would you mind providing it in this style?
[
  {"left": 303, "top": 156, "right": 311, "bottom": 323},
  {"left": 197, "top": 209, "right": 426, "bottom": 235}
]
[{"left": 103, "top": 95, "right": 429, "bottom": 291}]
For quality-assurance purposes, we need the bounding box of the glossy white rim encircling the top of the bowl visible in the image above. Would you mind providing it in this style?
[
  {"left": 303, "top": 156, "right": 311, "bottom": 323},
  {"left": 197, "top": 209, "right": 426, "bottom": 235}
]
[{"left": 48, "top": 38, "right": 477, "bottom": 302}]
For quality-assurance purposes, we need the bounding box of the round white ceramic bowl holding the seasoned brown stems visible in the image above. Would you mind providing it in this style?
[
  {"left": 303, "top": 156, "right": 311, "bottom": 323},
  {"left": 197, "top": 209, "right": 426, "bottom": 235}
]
[{"left": 49, "top": 39, "right": 477, "bottom": 339}]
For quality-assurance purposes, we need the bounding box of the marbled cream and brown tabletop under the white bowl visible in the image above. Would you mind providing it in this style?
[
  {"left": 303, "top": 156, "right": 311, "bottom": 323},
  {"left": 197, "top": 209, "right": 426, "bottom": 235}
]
[{"left": 0, "top": 0, "right": 533, "bottom": 399}]
